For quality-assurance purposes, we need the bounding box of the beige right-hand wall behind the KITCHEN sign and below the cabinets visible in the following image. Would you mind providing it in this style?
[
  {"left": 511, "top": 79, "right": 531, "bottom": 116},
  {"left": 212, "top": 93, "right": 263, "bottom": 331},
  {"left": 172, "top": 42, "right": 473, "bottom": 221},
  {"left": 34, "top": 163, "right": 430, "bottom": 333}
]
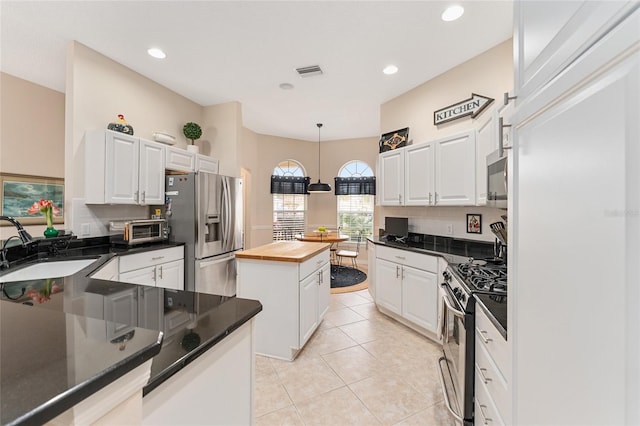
[{"left": 375, "top": 40, "right": 513, "bottom": 241}]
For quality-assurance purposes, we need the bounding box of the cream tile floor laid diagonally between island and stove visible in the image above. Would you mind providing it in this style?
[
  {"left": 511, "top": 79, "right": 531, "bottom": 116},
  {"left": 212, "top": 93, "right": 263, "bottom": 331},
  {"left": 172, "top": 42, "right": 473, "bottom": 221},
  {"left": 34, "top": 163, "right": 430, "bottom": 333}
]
[{"left": 254, "top": 290, "right": 454, "bottom": 426}]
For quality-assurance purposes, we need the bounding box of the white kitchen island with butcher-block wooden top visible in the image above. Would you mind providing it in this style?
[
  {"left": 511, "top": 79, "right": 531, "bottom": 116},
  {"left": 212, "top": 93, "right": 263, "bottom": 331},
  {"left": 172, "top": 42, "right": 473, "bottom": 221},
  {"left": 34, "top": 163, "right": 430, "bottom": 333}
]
[{"left": 236, "top": 241, "right": 331, "bottom": 361}]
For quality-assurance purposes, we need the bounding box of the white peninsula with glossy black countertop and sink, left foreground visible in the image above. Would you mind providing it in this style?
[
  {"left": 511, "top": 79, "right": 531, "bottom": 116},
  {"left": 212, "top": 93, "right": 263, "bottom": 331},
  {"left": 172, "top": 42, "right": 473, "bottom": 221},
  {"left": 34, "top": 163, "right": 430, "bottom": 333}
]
[{"left": 0, "top": 238, "right": 261, "bottom": 424}]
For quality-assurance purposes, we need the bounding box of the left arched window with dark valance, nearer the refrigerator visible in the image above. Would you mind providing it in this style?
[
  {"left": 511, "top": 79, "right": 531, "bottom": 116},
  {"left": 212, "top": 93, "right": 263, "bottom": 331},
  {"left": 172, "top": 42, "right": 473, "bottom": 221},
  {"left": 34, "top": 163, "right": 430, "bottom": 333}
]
[{"left": 271, "top": 160, "right": 308, "bottom": 241}]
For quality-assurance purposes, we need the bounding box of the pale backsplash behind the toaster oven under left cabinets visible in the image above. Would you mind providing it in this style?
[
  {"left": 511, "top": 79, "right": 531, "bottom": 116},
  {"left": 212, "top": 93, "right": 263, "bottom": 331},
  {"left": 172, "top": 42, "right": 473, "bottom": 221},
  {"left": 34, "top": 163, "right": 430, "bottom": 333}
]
[{"left": 71, "top": 198, "right": 149, "bottom": 238}]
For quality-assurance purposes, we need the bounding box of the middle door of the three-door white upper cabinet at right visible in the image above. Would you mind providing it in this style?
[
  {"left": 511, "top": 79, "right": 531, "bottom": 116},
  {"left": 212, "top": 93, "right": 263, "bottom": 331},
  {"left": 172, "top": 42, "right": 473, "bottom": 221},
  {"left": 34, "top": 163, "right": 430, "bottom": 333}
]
[{"left": 403, "top": 143, "right": 435, "bottom": 206}]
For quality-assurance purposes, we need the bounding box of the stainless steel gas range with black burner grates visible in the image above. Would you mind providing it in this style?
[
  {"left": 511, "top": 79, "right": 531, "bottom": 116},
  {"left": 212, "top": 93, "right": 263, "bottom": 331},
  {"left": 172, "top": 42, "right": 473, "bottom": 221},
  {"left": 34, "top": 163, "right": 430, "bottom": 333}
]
[{"left": 439, "top": 259, "right": 507, "bottom": 425}]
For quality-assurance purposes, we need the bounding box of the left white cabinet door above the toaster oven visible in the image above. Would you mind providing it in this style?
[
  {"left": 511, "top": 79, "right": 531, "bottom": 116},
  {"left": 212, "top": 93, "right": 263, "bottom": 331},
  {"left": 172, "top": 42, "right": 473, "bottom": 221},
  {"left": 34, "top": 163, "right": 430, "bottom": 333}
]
[{"left": 105, "top": 132, "right": 139, "bottom": 204}]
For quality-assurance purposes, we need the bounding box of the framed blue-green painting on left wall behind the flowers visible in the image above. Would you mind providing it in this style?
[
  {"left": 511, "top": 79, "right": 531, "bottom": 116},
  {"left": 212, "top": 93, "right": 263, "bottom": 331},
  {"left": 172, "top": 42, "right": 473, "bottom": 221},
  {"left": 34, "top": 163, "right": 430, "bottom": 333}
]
[{"left": 0, "top": 173, "right": 64, "bottom": 226}]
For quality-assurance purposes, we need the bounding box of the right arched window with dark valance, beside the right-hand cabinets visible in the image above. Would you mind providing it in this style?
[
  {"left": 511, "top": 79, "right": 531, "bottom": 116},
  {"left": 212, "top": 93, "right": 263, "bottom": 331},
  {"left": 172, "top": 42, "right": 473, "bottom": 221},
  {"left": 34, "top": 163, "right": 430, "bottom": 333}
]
[{"left": 336, "top": 160, "right": 375, "bottom": 241}]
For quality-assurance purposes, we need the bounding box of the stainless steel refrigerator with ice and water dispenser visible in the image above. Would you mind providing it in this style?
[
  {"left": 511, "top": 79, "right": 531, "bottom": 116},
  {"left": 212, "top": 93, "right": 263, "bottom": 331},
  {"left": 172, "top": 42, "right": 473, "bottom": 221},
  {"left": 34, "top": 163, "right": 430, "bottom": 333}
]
[{"left": 164, "top": 172, "right": 243, "bottom": 296}]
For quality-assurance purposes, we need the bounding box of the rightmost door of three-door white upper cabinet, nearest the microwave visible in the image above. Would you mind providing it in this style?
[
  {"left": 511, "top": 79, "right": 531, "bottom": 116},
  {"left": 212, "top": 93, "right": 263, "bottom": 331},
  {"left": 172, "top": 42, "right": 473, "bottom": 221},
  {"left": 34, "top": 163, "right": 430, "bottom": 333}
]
[{"left": 435, "top": 130, "right": 476, "bottom": 206}]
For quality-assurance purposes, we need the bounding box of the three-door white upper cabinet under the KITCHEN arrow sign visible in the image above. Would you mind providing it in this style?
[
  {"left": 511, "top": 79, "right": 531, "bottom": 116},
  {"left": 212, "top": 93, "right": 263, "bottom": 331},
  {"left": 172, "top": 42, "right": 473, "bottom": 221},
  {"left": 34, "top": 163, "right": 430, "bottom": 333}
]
[{"left": 378, "top": 131, "right": 476, "bottom": 206}]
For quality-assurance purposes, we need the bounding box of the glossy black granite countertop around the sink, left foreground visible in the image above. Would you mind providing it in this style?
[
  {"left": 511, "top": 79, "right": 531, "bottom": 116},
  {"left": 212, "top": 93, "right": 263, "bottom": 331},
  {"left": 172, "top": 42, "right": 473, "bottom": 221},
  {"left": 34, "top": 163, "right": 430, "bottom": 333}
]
[{"left": 0, "top": 243, "right": 262, "bottom": 424}]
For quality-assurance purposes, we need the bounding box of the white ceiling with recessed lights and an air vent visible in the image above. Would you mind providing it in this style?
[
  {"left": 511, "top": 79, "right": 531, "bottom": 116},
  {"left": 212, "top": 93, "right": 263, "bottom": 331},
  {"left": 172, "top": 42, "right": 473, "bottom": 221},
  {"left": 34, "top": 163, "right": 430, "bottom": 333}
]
[{"left": 0, "top": 0, "right": 512, "bottom": 140}]
